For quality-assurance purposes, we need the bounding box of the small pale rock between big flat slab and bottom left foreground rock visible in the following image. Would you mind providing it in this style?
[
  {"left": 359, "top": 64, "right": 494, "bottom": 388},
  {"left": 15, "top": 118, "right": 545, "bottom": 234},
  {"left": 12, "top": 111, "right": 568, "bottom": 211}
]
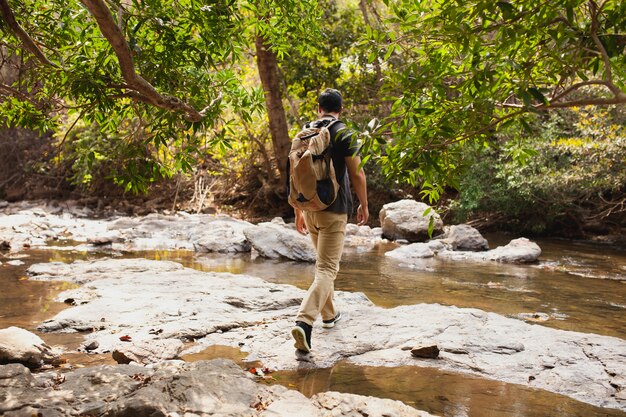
[{"left": 111, "top": 339, "right": 184, "bottom": 365}]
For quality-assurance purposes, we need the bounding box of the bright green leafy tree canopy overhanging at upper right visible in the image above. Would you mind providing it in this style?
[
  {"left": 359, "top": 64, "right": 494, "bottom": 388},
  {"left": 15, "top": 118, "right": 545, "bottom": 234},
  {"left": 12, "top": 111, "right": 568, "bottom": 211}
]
[{"left": 365, "top": 0, "right": 626, "bottom": 198}]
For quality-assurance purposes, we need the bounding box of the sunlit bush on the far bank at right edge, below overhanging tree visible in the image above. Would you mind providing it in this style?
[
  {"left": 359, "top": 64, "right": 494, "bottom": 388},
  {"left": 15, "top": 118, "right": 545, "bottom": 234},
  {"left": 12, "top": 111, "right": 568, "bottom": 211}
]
[{"left": 451, "top": 105, "right": 626, "bottom": 235}]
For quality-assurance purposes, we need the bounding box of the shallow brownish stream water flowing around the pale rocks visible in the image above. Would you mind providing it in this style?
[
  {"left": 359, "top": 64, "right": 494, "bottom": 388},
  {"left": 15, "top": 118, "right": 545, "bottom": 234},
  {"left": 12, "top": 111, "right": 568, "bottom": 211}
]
[{"left": 0, "top": 236, "right": 626, "bottom": 417}]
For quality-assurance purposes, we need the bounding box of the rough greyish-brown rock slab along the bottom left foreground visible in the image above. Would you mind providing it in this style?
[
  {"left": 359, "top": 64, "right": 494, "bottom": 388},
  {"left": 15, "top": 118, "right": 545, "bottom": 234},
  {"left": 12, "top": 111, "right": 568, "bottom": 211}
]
[{"left": 0, "top": 359, "right": 430, "bottom": 417}]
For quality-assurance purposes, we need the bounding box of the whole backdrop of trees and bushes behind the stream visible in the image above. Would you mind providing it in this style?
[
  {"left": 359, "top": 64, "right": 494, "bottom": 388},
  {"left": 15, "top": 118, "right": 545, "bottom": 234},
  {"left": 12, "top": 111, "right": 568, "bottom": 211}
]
[{"left": 0, "top": 0, "right": 626, "bottom": 240}]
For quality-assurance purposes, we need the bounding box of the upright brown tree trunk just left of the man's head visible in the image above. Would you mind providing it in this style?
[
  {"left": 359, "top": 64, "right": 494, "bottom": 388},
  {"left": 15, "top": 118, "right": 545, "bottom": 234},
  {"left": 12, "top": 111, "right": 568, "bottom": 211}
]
[{"left": 255, "top": 36, "right": 291, "bottom": 184}]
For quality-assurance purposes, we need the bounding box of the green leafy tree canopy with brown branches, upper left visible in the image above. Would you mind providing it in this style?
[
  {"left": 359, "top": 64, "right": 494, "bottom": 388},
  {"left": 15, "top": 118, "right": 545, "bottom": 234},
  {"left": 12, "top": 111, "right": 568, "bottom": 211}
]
[{"left": 0, "top": 0, "right": 316, "bottom": 189}]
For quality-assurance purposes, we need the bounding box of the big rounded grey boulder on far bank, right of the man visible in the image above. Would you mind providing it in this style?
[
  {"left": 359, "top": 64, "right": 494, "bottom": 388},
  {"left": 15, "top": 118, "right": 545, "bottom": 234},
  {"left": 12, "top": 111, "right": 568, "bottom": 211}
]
[{"left": 379, "top": 200, "right": 443, "bottom": 242}]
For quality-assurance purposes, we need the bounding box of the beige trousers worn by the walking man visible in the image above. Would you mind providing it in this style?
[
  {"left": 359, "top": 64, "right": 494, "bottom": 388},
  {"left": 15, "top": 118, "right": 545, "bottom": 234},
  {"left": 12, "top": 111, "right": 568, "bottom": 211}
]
[{"left": 296, "top": 211, "right": 348, "bottom": 326}]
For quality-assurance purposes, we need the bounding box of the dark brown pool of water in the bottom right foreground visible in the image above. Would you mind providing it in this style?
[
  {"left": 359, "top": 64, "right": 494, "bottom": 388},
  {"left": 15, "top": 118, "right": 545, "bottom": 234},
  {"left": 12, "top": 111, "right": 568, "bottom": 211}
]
[{"left": 274, "top": 362, "right": 626, "bottom": 417}]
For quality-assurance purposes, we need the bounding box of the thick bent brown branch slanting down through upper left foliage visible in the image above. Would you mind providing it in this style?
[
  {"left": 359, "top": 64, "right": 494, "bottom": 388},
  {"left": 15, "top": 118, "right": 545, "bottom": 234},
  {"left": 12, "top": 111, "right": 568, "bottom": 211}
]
[{"left": 79, "top": 0, "right": 204, "bottom": 122}]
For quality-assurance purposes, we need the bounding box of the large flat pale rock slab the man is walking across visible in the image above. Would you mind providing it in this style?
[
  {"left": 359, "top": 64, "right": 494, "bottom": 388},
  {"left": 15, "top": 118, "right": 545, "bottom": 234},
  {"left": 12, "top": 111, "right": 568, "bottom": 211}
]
[{"left": 26, "top": 259, "right": 626, "bottom": 410}]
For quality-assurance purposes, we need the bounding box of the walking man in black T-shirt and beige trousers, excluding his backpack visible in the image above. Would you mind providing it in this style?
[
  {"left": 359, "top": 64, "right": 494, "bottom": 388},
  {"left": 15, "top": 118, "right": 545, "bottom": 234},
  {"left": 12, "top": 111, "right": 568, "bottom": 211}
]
[{"left": 291, "top": 88, "right": 369, "bottom": 353}]
